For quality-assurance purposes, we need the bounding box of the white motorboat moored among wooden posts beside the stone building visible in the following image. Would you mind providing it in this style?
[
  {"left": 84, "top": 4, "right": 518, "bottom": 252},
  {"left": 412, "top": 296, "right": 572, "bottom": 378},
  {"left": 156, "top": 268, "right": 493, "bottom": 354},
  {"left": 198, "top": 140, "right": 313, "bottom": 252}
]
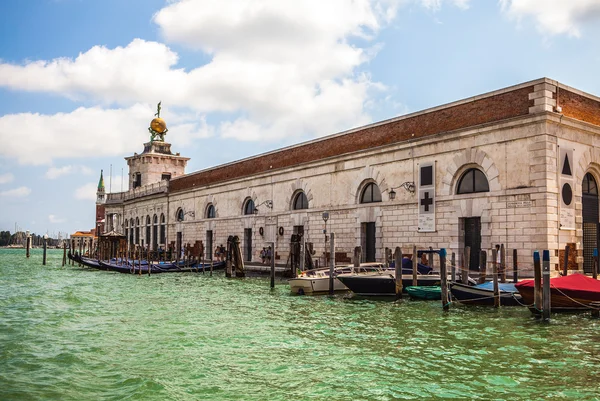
[{"left": 288, "top": 263, "right": 385, "bottom": 295}]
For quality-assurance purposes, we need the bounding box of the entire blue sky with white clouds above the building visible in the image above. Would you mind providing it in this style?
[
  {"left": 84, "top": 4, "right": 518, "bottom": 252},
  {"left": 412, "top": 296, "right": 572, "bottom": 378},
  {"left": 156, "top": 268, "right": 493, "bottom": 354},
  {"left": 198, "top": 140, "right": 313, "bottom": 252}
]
[{"left": 0, "top": 0, "right": 600, "bottom": 236}]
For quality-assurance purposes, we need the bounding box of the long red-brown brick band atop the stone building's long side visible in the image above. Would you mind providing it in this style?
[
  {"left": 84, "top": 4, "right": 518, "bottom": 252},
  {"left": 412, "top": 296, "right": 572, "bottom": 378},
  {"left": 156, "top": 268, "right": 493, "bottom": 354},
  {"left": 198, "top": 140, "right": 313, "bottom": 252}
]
[{"left": 169, "top": 87, "right": 536, "bottom": 192}]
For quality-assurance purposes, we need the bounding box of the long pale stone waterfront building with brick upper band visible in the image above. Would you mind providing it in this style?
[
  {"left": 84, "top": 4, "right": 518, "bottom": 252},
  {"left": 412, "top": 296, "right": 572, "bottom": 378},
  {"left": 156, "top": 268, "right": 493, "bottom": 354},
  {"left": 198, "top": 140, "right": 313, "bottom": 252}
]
[{"left": 106, "top": 78, "right": 600, "bottom": 270}]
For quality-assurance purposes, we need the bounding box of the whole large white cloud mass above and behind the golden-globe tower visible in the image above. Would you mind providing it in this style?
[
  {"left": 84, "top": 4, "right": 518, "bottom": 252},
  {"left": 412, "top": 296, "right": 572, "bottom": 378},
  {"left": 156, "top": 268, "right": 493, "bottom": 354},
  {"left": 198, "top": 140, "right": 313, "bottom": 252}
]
[{"left": 0, "top": 0, "right": 404, "bottom": 152}]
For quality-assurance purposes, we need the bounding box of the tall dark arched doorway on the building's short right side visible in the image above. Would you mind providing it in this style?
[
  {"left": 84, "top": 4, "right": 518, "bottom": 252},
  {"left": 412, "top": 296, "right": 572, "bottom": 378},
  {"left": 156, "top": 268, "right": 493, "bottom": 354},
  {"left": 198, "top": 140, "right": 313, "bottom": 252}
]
[{"left": 581, "top": 173, "right": 600, "bottom": 274}]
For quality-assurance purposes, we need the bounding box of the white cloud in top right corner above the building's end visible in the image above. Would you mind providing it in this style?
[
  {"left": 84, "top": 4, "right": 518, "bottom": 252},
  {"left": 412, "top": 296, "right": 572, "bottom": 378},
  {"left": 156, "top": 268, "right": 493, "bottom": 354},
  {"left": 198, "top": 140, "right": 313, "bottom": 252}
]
[{"left": 499, "top": 0, "right": 600, "bottom": 37}]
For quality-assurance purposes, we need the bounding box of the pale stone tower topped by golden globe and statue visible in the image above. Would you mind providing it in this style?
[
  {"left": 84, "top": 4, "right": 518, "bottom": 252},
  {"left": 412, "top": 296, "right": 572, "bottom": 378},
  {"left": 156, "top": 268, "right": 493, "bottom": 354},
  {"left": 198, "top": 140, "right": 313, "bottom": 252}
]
[{"left": 125, "top": 102, "right": 190, "bottom": 191}]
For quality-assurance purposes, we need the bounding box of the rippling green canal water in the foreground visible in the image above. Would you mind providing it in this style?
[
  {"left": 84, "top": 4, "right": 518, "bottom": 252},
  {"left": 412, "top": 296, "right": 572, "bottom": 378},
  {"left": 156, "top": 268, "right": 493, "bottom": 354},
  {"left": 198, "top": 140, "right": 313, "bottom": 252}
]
[{"left": 0, "top": 249, "right": 600, "bottom": 400}]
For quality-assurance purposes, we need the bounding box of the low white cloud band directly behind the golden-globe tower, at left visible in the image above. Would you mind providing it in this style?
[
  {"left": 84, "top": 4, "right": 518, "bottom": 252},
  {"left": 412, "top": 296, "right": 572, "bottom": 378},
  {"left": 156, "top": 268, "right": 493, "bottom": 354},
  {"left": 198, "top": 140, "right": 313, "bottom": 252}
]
[{"left": 0, "top": 104, "right": 206, "bottom": 166}]
